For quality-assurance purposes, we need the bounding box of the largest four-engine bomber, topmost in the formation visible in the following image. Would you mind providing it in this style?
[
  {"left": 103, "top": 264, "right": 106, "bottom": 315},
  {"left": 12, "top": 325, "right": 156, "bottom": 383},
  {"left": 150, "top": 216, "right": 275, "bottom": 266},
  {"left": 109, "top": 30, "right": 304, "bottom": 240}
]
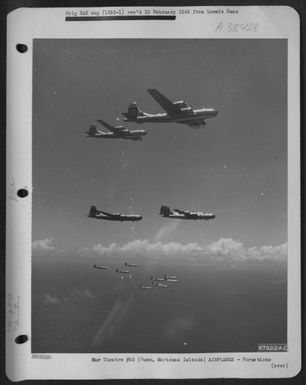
[{"left": 122, "top": 88, "right": 218, "bottom": 128}]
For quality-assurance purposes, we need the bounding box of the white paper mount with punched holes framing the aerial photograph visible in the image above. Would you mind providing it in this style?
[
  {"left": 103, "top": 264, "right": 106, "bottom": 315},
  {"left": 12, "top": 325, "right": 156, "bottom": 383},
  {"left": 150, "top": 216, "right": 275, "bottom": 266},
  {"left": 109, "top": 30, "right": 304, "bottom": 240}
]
[{"left": 6, "top": 6, "right": 301, "bottom": 381}]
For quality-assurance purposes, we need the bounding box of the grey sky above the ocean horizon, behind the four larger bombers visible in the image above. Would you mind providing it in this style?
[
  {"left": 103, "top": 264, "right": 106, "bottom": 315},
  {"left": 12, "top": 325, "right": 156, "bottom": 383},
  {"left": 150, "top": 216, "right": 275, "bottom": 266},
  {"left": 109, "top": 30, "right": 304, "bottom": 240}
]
[{"left": 32, "top": 39, "right": 287, "bottom": 257}]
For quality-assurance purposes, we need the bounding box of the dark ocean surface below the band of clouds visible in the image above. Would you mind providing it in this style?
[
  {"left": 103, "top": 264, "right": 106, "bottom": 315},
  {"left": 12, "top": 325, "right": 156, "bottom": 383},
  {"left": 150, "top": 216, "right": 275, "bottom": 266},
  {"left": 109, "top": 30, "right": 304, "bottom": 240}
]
[{"left": 31, "top": 256, "right": 287, "bottom": 353}]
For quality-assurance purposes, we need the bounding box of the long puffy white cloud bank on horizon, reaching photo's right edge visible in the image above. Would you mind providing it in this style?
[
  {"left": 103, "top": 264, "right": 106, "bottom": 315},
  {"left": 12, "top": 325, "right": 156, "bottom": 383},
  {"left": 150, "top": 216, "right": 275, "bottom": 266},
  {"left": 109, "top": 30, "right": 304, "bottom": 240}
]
[{"left": 79, "top": 237, "right": 288, "bottom": 261}]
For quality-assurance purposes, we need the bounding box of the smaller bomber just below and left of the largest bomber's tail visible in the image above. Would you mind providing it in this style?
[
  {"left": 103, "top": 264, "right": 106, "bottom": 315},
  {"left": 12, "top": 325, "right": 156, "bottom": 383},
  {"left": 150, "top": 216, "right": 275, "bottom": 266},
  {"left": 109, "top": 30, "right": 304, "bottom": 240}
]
[{"left": 86, "top": 119, "right": 147, "bottom": 140}]
